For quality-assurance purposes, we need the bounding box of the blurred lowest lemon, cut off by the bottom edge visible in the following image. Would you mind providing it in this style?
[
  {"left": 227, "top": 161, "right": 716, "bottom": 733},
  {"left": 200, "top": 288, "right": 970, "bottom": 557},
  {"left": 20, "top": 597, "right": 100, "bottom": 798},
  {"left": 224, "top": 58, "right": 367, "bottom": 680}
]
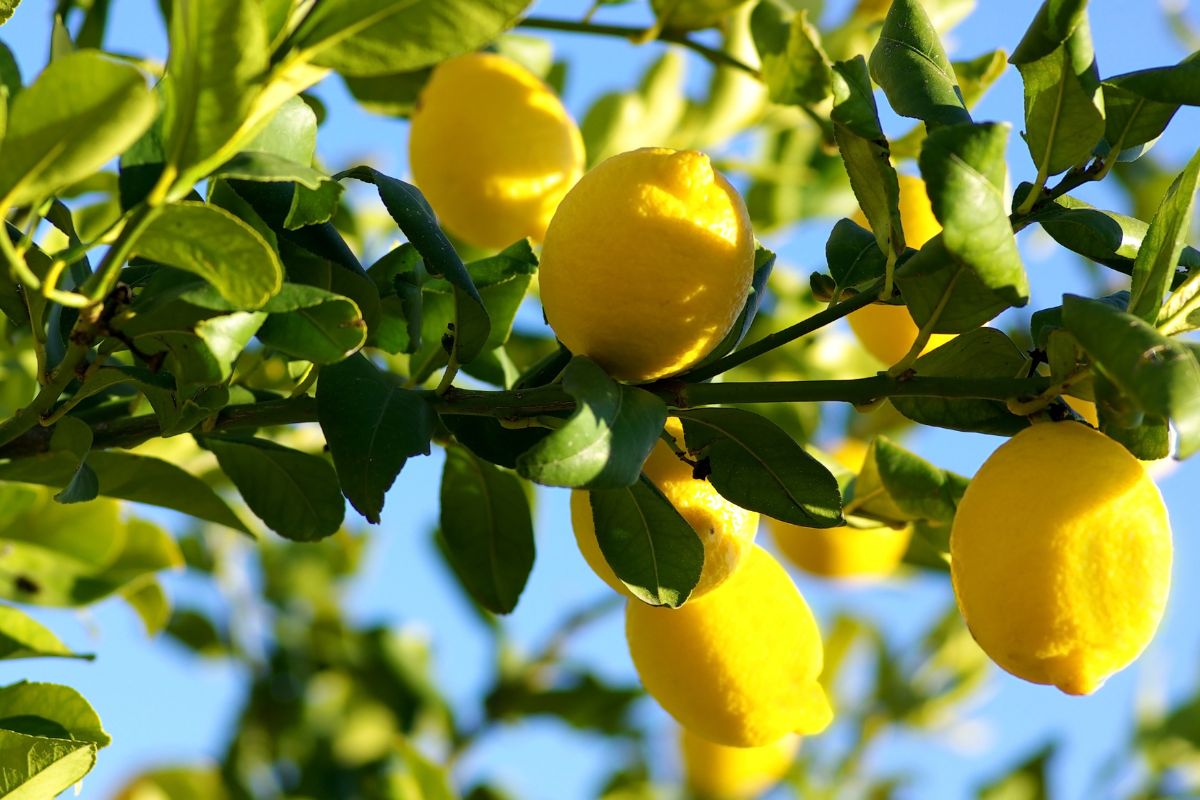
[{"left": 679, "top": 728, "right": 800, "bottom": 800}]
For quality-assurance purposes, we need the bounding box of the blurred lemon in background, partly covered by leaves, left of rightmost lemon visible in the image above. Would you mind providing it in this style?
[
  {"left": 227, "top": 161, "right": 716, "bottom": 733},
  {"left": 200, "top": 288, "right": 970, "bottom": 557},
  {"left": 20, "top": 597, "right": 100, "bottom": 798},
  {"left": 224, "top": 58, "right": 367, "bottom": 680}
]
[{"left": 767, "top": 439, "right": 912, "bottom": 578}]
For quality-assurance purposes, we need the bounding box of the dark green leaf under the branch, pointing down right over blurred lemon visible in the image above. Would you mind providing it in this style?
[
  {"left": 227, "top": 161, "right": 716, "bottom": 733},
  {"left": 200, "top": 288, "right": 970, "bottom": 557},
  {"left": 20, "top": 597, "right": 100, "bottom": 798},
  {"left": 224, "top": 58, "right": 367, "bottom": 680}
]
[{"left": 679, "top": 408, "right": 842, "bottom": 528}]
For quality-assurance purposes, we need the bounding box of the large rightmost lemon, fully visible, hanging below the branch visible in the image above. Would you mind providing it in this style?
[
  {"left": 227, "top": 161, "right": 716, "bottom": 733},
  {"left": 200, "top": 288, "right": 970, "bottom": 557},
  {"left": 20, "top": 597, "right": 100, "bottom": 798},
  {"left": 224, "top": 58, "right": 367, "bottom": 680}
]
[{"left": 950, "top": 422, "right": 1171, "bottom": 694}]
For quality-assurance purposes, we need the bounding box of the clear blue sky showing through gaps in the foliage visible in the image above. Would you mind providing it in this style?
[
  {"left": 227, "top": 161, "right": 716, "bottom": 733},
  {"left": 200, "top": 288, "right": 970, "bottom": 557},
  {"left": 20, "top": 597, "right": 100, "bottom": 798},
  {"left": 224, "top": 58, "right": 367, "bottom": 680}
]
[{"left": 0, "top": 0, "right": 1200, "bottom": 800}]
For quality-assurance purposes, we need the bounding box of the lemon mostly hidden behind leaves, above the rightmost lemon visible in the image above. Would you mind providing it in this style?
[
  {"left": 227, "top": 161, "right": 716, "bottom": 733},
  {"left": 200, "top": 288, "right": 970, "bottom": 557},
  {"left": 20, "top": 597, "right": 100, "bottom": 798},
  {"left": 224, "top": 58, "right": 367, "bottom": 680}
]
[{"left": 846, "top": 175, "right": 954, "bottom": 365}]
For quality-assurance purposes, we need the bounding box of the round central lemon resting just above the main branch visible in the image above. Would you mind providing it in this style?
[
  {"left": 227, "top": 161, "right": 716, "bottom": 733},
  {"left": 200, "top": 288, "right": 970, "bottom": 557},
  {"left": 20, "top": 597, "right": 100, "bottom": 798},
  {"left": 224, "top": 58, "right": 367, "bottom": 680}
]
[{"left": 539, "top": 148, "right": 754, "bottom": 381}]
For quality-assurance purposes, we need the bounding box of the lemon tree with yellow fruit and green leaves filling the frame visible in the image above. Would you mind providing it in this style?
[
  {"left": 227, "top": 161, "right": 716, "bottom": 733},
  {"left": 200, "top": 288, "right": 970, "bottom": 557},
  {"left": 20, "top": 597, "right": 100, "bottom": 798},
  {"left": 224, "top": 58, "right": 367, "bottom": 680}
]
[{"left": 0, "top": 0, "right": 1200, "bottom": 800}]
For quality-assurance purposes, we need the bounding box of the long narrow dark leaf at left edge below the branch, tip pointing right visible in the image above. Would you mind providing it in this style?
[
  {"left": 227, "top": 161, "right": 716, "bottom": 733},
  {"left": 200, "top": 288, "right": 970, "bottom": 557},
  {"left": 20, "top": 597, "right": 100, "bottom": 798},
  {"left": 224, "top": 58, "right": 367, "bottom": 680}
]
[{"left": 0, "top": 450, "right": 250, "bottom": 533}]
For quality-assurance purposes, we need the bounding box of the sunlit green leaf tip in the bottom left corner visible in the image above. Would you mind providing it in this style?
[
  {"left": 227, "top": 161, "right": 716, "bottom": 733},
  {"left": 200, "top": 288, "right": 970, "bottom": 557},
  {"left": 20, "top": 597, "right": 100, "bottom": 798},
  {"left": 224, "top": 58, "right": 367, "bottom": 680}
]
[{"left": 0, "top": 730, "right": 96, "bottom": 800}]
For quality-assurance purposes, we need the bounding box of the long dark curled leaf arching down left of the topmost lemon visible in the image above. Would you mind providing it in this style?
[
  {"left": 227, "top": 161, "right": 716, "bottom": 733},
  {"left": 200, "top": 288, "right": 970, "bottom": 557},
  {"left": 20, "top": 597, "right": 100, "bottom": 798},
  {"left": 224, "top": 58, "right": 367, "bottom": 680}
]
[{"left": 337, "top": 172, "right": 491, "bottom": 363}]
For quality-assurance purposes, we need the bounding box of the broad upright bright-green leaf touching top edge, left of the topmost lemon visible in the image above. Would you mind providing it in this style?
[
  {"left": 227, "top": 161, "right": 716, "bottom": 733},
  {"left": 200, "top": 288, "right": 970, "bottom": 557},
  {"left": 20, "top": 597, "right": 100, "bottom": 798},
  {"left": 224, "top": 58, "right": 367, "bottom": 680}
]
[{"left": 162, "top": 0, "right": 270, "bottom": 188}]
